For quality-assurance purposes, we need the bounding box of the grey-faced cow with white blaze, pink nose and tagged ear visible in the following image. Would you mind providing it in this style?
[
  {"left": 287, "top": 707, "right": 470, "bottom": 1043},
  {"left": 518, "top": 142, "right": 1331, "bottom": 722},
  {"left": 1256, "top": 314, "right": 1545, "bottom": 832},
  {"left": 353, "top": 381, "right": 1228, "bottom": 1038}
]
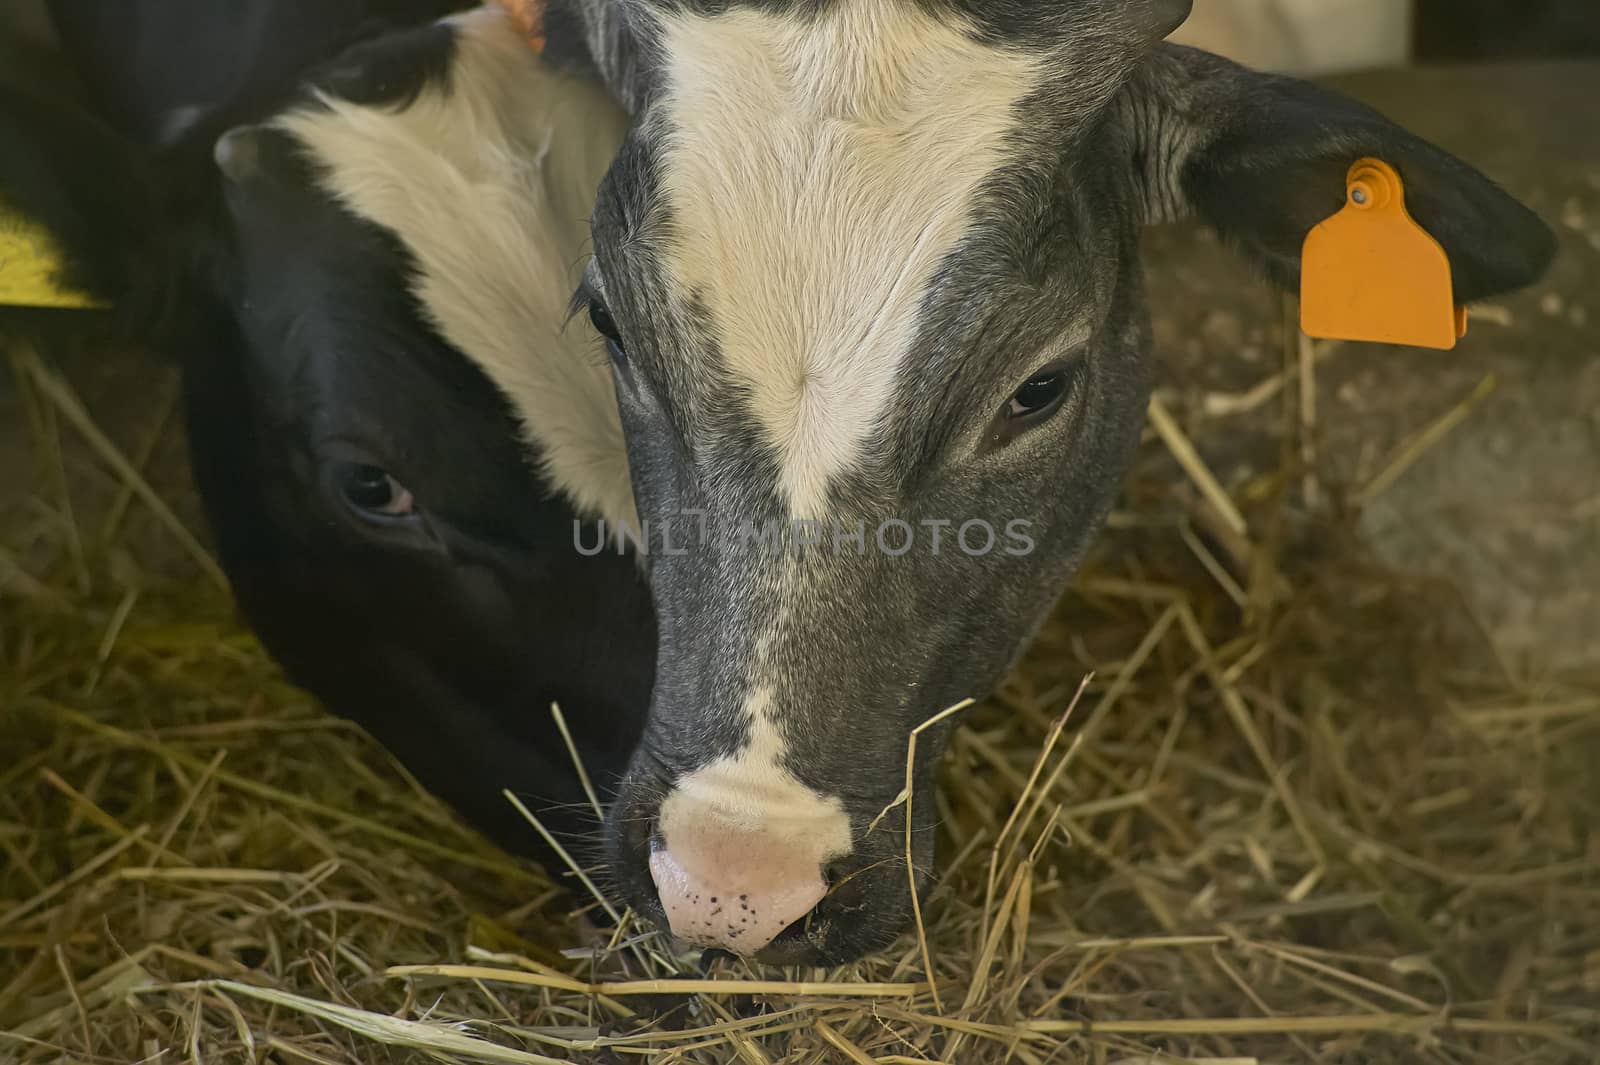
[{"left": 492, "top": 0, "right": 1554, "bottom": 964}]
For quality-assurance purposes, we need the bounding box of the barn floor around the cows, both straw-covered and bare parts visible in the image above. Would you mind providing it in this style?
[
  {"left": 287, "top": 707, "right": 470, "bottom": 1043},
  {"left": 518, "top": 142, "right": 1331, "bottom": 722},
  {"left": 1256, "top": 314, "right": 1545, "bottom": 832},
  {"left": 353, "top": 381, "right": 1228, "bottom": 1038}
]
[{"left": 0, "top": 64, "right": 1600, "bottom": 1065}]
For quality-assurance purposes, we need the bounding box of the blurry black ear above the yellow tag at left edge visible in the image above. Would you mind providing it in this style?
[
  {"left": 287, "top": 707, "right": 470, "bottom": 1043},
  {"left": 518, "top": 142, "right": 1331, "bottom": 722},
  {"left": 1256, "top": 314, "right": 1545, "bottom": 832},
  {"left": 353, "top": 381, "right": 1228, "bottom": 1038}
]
[{"left": 0, "top": 82, "right": 163, "bottom": 310}]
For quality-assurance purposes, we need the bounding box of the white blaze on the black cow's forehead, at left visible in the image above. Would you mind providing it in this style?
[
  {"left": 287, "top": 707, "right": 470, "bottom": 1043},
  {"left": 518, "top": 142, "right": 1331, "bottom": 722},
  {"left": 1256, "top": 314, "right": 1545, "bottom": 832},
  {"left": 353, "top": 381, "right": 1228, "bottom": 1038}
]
[{"left": 277, "top": 8, "right": 637, "bottom": 528}]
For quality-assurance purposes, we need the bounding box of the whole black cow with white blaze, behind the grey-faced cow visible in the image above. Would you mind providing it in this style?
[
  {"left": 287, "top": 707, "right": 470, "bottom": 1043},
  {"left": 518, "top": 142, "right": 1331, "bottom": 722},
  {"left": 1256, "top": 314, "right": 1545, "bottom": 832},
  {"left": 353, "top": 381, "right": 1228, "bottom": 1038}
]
[{"left": 0, "top": 0, "right": 656, "bottom": 862}]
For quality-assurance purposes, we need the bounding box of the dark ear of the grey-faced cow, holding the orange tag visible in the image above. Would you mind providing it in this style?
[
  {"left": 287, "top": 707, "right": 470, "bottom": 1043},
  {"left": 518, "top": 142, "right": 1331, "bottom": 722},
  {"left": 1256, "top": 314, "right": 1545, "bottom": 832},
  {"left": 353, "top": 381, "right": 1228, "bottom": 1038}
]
[{"left": 1117, "top": 45, "right": 1555, "bottom": 302}]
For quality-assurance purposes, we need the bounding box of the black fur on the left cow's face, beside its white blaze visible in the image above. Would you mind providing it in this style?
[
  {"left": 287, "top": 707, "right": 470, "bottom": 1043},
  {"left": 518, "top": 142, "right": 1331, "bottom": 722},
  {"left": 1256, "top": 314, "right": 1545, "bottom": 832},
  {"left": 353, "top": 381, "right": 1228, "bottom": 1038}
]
[{"left": 187, "top": 131, "right": 656, "bottom": 857}]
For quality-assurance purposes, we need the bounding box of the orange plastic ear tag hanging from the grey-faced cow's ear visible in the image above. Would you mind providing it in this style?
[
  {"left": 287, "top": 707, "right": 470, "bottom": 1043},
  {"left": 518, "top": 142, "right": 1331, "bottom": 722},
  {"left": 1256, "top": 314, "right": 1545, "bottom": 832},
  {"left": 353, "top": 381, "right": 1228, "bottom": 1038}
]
[{"left": 1301, "top": 158, "right": 1467, "bottom": 350}]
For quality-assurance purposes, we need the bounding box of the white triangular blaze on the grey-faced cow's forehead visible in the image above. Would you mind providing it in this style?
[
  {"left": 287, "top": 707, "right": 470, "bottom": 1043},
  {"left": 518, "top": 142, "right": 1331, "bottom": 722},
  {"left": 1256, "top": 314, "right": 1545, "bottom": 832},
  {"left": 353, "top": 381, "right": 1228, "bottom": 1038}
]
[{"left": 661, "top": 0, "right": 1043, "bottom": 517}]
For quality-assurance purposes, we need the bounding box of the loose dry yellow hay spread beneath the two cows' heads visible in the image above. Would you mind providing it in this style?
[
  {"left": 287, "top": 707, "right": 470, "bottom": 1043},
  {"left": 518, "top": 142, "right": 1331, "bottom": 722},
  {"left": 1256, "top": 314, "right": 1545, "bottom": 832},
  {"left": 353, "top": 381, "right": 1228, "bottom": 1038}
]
[{"left": 0, "top": 332, "right": 1600, "bottom": 1065}]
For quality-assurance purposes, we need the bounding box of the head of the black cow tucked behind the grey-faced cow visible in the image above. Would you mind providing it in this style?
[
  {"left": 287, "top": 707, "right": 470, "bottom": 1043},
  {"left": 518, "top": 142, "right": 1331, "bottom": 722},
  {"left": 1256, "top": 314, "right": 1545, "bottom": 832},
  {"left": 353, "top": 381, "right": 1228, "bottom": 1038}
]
[{"left": 204, "top": 11, "right": 654, "bottom": 857}]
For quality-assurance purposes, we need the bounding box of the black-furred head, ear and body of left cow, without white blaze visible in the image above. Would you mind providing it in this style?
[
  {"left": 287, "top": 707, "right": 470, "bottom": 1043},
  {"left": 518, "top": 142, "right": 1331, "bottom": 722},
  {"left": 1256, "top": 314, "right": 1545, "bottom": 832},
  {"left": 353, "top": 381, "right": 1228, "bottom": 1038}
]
[{"left": 0, "top": 0, "right": 654, "bottom": 859}]
